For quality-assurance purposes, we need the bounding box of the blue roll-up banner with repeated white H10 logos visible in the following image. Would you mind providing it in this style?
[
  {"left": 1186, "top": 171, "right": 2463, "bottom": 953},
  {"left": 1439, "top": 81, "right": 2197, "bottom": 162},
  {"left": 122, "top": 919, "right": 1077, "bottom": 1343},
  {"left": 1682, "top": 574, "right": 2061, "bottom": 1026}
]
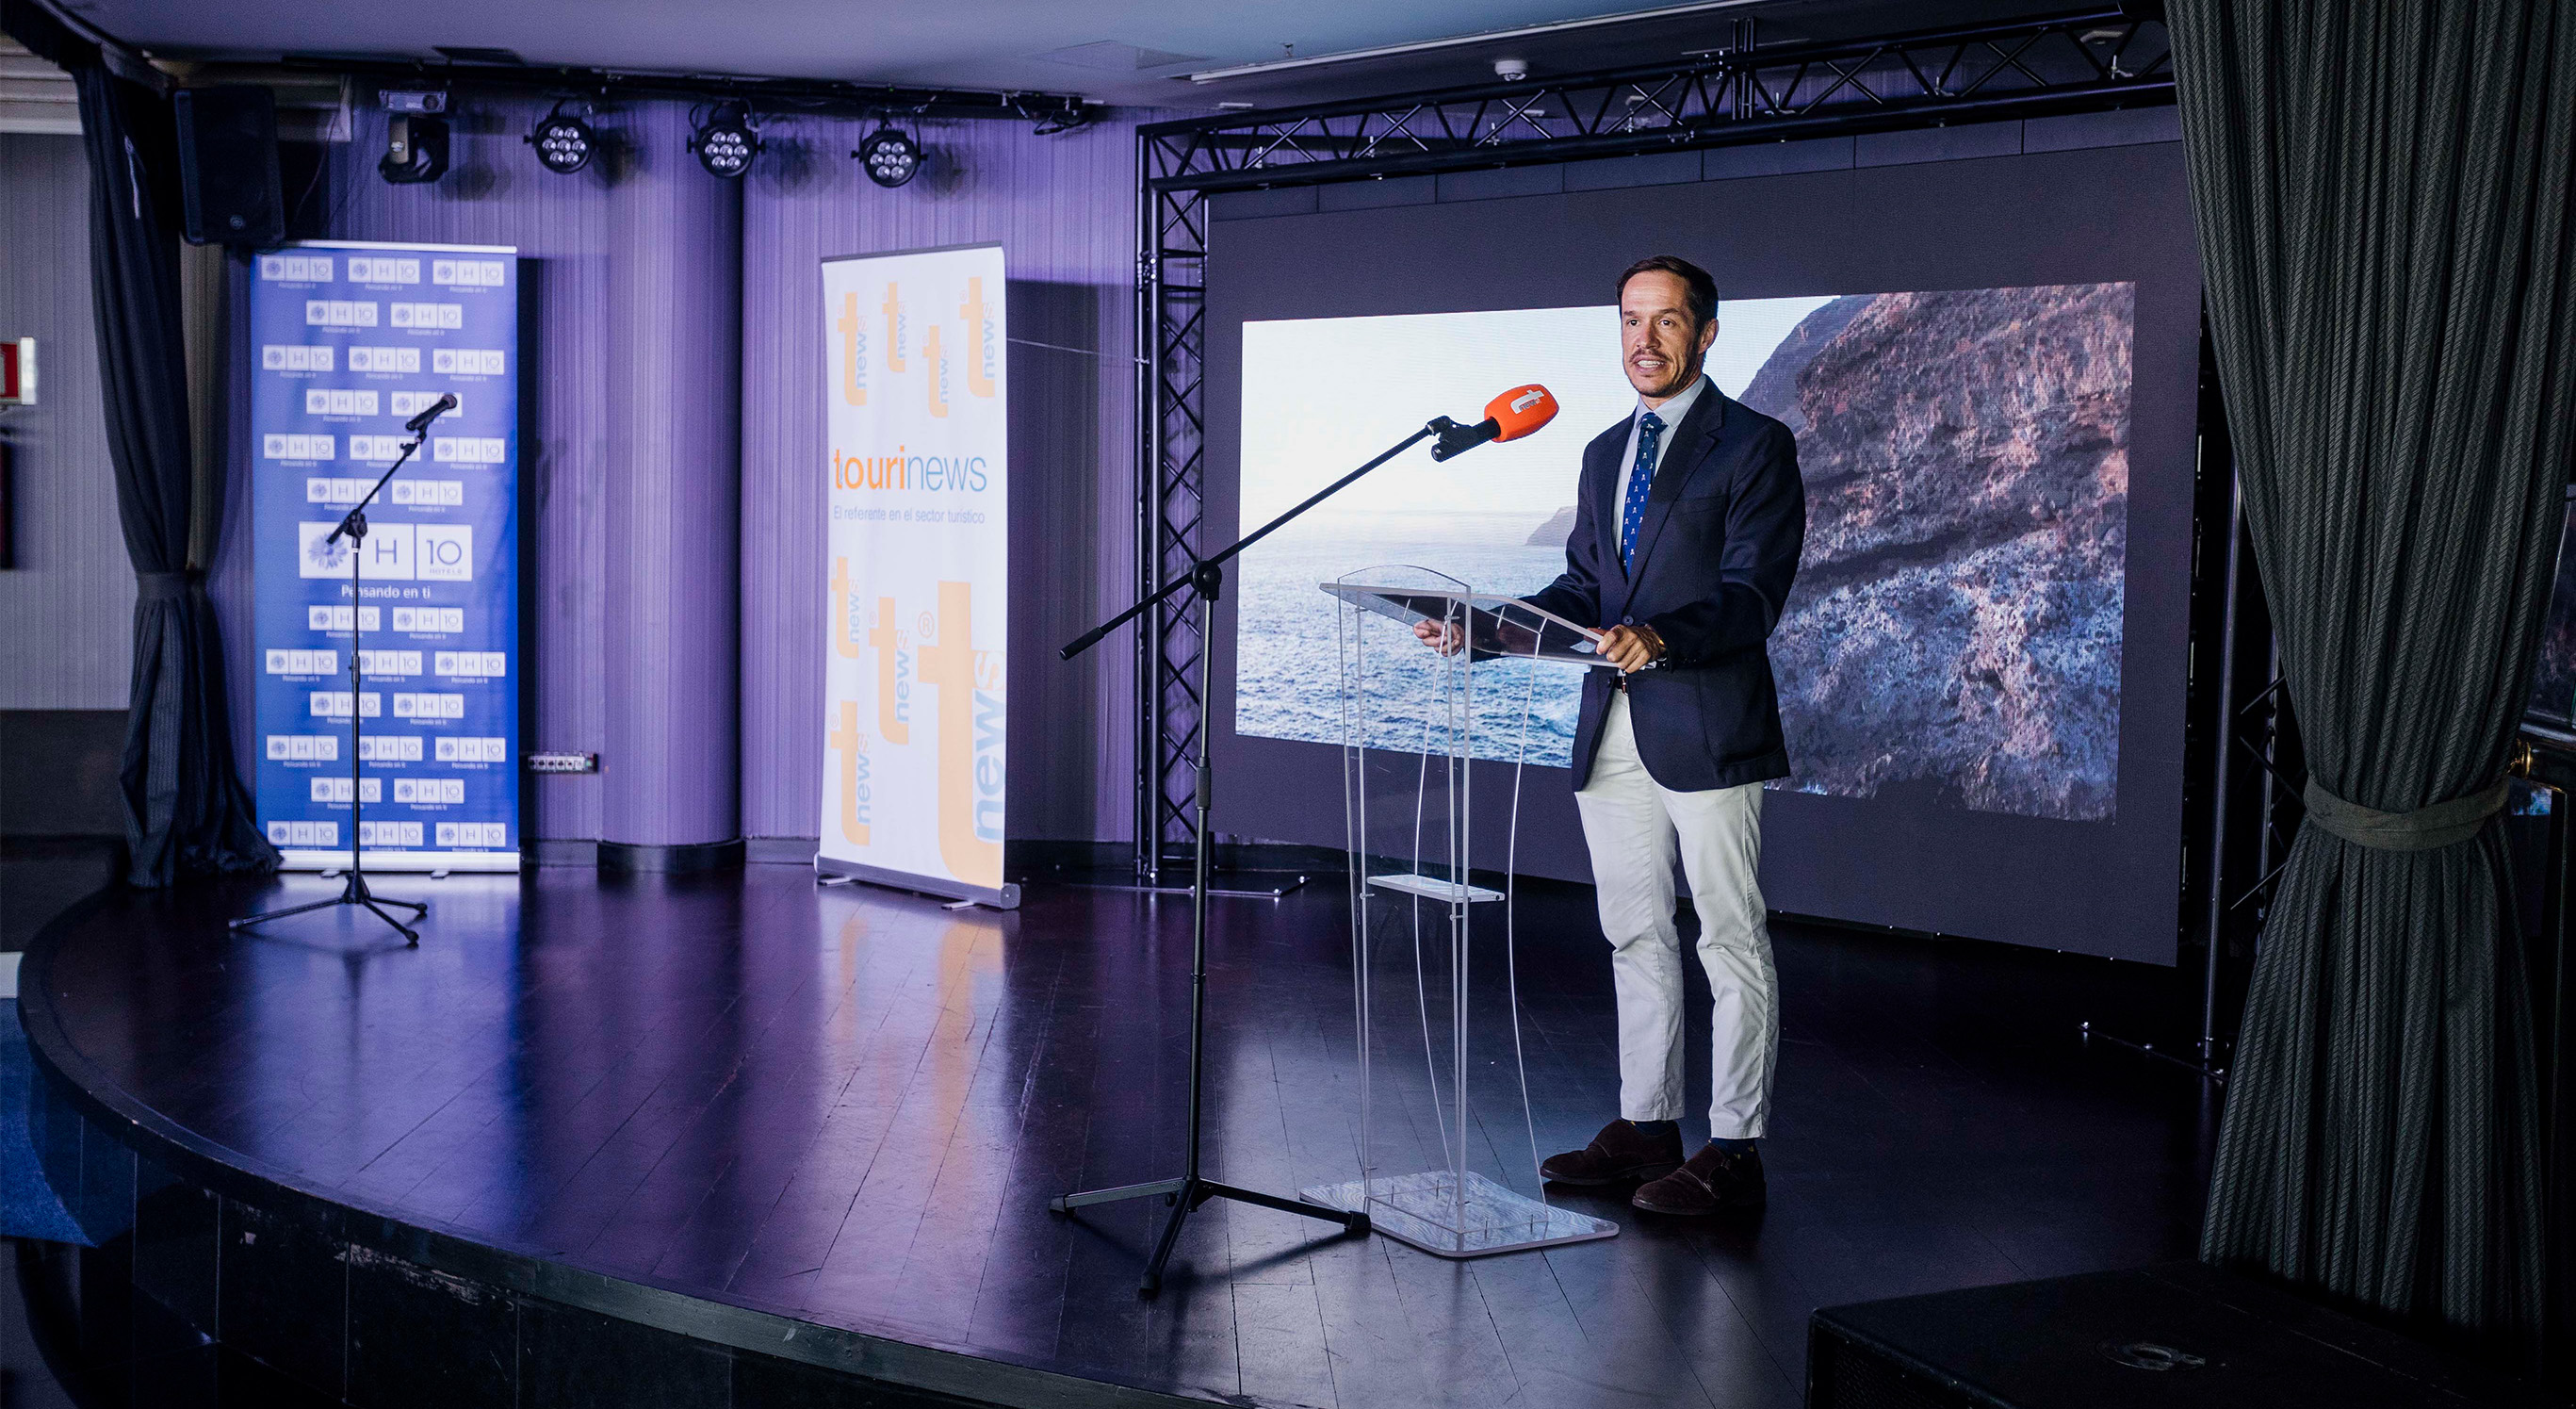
[{"left": 250, "top": 242, "right": 520, "bottom": 871}]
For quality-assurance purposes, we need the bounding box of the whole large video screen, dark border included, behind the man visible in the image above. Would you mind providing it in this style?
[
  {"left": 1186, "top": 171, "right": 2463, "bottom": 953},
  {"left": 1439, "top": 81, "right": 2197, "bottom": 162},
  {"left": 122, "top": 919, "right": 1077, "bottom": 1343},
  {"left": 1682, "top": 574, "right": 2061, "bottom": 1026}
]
[{"left": 1206, "top": 138, "right": 2223, "bottom": 963}]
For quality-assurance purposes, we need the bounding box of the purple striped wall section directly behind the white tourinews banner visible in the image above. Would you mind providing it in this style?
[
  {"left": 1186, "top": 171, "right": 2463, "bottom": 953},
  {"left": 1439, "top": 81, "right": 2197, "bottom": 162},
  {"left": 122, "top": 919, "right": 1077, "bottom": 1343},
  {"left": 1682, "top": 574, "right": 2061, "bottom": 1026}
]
[{"left": 742, "top": 113, "right": 1136, "bottom": 840}]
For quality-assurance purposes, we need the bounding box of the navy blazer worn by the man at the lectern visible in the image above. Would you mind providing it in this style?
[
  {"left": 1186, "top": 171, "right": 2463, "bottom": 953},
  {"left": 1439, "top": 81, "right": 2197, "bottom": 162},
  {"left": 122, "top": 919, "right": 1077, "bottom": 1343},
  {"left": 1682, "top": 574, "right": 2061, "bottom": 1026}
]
[{"left": 1525, "top": 386, "right": 1806, "bottom": 791}]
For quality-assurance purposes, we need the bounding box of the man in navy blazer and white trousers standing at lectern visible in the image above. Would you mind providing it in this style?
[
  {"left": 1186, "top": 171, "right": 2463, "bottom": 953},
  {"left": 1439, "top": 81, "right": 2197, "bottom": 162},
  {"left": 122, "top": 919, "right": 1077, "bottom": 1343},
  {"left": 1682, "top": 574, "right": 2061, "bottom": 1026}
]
[{"left": 1417, "top": 255, "right": 1806, "bottom": 1213}]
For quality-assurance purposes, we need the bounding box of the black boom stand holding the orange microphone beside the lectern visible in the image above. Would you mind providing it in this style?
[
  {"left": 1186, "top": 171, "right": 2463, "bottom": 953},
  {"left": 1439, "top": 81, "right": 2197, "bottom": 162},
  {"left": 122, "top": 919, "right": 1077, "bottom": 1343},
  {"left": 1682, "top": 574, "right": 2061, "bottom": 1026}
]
[{"left": 1046, "top": 415, "right": 1492, "bottom": 1296}]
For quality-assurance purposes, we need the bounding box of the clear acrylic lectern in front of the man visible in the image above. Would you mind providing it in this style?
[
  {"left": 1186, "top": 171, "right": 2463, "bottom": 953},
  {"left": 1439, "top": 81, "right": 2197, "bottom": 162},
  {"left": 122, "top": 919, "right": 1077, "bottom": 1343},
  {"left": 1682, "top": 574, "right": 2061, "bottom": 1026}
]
[{"left": 1301, "top": 566, "right": 1618, "bottom": 1257}]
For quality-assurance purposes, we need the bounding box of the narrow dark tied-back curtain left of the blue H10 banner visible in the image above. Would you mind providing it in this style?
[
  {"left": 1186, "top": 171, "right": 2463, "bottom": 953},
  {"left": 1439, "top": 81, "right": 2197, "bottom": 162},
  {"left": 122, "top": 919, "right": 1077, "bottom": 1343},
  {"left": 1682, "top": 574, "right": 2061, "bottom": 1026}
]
[{"left": 0, "top": 0, "right": 278, "bottom": 886}]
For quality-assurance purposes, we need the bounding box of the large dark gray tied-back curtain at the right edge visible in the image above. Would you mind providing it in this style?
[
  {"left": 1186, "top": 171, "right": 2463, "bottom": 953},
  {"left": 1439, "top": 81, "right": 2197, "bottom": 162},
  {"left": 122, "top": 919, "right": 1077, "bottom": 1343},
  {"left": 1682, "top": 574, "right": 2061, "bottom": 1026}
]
[{"left": 2169, "top": 0, "right": 2576, "bottom": 1363}]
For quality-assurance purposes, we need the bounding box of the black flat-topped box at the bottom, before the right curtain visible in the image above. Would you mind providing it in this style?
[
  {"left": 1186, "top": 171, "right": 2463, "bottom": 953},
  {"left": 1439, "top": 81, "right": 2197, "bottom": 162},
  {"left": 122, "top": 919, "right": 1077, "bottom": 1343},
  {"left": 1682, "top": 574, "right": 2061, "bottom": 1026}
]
[{"left": 1806, "top": 1262, "right": 2561, "bottom": 1409}]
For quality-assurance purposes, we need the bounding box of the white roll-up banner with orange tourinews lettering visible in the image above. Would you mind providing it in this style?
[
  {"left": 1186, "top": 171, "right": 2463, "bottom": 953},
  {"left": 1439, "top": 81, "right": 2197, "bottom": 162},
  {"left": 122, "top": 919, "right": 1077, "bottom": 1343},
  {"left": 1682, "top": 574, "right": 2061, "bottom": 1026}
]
[{"left": 814, "top": 245, "right": 1020, "bottom": 907}]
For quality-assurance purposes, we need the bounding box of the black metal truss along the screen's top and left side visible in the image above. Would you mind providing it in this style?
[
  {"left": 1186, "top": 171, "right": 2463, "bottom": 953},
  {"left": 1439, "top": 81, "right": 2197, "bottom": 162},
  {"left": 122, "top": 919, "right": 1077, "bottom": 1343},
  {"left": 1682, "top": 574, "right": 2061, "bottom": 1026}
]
[{"left": 1136, "top": 5, "right": 2174, "bottom": 883}]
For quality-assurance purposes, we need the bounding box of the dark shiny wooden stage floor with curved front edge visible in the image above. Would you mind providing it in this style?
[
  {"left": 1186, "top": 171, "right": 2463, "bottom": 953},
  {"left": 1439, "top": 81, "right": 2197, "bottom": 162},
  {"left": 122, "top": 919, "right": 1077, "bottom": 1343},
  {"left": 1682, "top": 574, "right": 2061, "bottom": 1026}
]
[{"left": 43, "top": 865, "right": 2215, "bottom": 1409}]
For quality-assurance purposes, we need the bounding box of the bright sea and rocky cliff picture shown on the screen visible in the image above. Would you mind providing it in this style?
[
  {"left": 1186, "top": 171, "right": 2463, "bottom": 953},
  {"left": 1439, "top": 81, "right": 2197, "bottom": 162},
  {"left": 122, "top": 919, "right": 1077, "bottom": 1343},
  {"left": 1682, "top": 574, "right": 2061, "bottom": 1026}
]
[{"left": 1236, "top": 284, "right": 2135, "bottom": 822}]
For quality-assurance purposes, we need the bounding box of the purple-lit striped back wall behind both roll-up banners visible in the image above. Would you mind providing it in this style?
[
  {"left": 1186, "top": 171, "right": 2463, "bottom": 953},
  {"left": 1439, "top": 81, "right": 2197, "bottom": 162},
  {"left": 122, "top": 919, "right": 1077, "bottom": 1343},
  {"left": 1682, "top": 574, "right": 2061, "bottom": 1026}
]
[{"left": 217, "top": 98, "right": 1157, "bottom": 843}]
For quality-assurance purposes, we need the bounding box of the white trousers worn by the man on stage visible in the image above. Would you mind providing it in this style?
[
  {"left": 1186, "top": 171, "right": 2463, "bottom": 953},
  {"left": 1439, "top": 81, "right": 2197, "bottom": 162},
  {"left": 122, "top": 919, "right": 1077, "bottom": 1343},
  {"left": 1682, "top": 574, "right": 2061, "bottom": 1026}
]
[{"left": 1573, "top": 693, "right": 1780, "bottom": 1139}]
